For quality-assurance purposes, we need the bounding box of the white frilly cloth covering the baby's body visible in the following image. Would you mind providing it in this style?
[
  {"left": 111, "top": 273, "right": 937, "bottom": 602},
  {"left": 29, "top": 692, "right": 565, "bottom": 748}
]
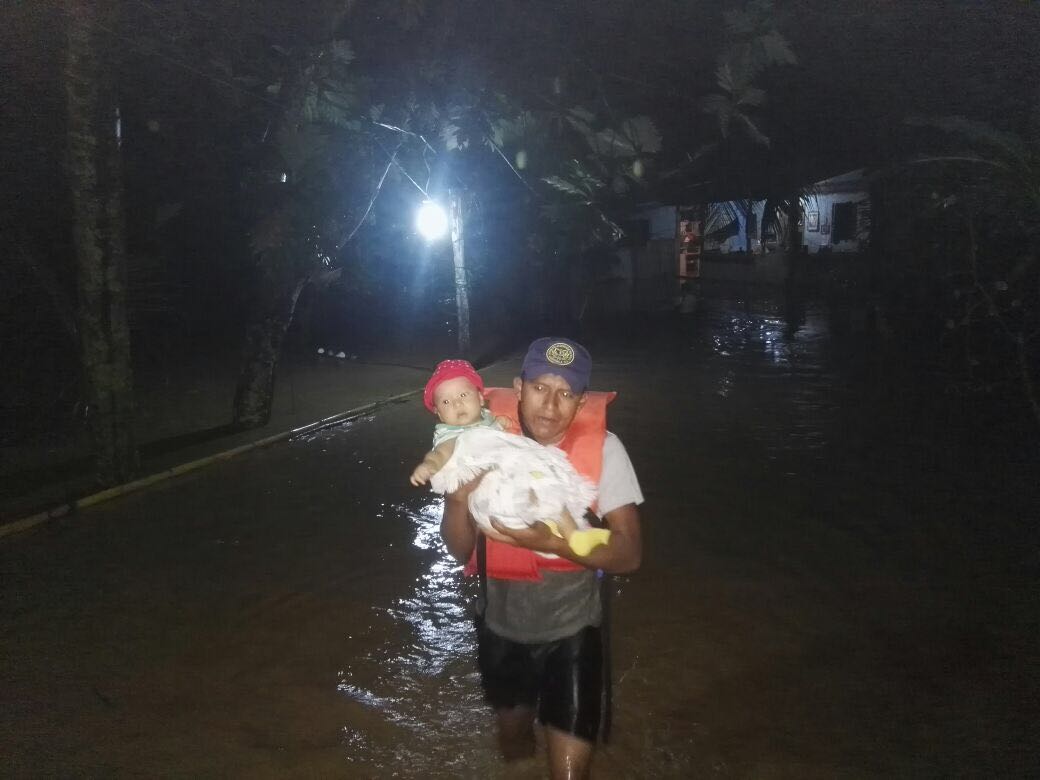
[{"left": 430, "top": 427, "right": 596, "bottom": 530}]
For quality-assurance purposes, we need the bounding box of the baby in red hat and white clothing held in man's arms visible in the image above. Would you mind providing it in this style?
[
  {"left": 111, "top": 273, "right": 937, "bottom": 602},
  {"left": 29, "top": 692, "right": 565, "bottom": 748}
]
[{"left": 411, "top": 360, "right": 609, "bottom": 556}]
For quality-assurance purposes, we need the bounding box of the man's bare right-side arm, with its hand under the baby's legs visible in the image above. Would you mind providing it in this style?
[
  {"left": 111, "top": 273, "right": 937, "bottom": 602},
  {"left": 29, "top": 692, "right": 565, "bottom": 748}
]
[{"left": 488, "top": 503, "right": 643, "bottom": 574}]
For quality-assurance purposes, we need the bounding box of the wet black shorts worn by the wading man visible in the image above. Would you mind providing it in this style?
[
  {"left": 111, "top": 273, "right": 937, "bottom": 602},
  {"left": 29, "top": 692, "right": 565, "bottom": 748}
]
[{"left": 477, "top": 626, "right": 603, "bottom": 742}]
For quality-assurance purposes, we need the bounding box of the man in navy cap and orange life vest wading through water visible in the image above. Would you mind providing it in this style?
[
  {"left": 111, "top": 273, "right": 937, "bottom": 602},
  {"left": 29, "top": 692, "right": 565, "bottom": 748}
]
[{"left": 441, "top": 338, "right": 643, "bottom": 778}]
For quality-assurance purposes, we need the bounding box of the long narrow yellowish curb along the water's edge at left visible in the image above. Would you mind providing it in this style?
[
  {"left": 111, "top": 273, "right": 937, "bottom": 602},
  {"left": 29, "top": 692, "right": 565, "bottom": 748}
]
[{"left": 0, "top": 389, "right": 422, "bottom": 539}]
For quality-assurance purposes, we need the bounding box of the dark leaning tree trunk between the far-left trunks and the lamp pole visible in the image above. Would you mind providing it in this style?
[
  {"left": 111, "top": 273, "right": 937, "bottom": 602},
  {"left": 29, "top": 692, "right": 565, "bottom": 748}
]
[{"left": 234, "top": 268, "right": 307, "bottom": 428}]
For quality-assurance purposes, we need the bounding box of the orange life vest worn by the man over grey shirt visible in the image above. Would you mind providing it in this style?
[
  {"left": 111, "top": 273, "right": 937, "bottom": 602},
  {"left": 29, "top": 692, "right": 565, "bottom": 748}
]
[{"left": 465, "top": 387, "right": 618, "bottom": 581}]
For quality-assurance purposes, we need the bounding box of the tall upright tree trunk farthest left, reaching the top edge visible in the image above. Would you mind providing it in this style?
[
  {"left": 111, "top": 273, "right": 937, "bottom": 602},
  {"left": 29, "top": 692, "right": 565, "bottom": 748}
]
[{"left": 64, "top": 2, "right": 138, "bottom": 485}]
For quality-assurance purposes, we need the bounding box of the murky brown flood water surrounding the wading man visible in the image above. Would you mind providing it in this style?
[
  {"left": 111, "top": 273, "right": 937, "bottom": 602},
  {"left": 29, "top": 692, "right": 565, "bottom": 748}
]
[{"left": 0, "top": 294, "right": 1040, "bottom": 778}]
